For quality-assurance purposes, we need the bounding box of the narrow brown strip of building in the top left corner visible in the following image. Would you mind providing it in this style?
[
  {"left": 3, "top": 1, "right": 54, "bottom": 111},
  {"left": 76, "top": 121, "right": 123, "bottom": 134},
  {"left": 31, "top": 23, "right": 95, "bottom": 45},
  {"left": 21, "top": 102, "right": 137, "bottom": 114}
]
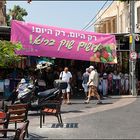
[{"left": 0, "top": 0, "right": 6, "bottom": 26}]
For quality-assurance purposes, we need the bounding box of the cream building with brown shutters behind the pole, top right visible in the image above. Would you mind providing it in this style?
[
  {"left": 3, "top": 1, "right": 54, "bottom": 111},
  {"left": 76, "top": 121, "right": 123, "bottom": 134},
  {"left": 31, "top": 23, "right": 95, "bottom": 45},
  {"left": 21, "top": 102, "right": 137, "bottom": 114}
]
[{"left": 94, "top": 1, "right": 140, "bottom": 33}]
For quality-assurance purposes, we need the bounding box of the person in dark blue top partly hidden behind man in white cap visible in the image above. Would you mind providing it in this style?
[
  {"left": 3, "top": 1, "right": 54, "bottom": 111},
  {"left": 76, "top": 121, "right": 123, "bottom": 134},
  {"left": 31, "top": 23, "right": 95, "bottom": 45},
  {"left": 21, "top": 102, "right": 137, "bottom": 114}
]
[{"left": 82, "top": 68, "right": 89, "bottom": 99}]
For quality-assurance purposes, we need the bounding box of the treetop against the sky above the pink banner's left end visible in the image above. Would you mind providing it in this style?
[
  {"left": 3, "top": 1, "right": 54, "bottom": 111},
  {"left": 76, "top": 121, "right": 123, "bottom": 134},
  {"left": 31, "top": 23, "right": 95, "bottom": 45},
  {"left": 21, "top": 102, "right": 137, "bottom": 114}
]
[{"left": 6, "top": 5, "right": 28, "bottom": 26}]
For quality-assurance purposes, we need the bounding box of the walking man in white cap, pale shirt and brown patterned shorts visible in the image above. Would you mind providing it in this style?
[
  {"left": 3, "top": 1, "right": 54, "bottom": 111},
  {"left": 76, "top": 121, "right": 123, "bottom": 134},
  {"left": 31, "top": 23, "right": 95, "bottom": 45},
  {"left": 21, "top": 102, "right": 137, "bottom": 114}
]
[{"left": 85, "top": 66, "right": 102, "bottom": 104}]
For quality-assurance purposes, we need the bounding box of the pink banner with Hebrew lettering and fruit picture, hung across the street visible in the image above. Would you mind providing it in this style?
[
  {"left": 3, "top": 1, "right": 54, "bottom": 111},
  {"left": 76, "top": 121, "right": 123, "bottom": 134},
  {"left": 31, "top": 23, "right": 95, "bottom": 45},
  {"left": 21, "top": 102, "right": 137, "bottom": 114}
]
[{"left": 11, "top": 20, "right": 117, "bottom": 64}]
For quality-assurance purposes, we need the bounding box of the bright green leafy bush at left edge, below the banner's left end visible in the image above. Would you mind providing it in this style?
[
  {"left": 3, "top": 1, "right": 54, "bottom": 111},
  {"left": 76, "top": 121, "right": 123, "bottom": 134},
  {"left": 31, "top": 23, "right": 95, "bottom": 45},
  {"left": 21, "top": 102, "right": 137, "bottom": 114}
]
[{"left": 0, "top": 40, "right": 22, "bottom": 67}]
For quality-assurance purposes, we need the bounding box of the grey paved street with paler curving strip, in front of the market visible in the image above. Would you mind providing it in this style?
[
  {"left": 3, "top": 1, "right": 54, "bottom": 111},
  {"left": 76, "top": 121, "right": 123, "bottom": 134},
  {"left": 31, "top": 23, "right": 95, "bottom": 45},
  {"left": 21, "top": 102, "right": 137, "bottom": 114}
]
[{"left": 16, "top": 97, "right": 140, "bottom": 139}]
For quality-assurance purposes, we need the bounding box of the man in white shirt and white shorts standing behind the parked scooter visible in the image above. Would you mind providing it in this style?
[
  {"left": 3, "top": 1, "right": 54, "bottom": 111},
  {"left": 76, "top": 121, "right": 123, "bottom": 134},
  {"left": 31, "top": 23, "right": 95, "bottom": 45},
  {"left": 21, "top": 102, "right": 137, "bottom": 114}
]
[{"left": 59, "top": 67, "right": 72, "bottom": 104}]
